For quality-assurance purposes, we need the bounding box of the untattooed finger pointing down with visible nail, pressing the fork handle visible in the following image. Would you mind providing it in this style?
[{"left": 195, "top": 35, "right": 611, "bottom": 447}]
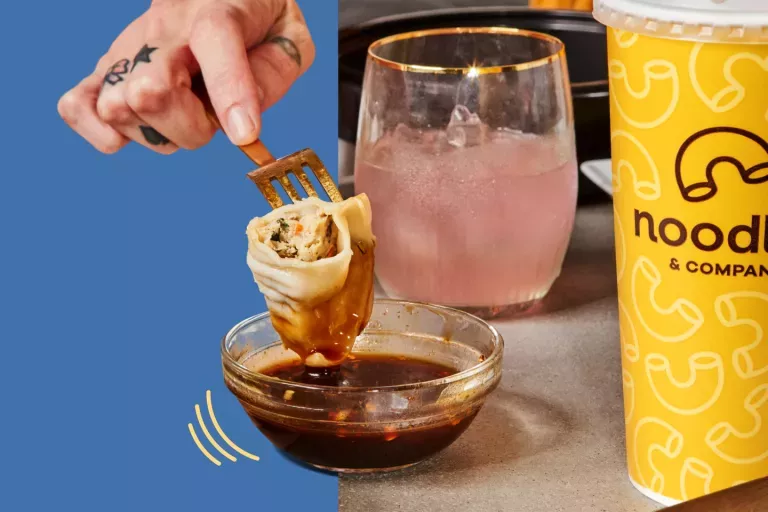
[{"left": 189, "top": 6, "right": 263, "bottom": 145}]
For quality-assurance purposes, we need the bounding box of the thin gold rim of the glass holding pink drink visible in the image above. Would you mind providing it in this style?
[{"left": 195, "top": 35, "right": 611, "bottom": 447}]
[{"left": 368, "top": 27, "right": 565, "bottom": 75}]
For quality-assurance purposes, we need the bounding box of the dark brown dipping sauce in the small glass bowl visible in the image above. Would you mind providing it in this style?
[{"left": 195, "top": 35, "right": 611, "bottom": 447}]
[{"left": 246, "top": 353, "right": 480, "bottom": 470}]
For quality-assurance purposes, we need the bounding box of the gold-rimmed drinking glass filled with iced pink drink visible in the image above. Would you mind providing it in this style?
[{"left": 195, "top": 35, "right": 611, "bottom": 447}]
[{"left": 355, "top": 28, "right": 578, "bottom": 318}]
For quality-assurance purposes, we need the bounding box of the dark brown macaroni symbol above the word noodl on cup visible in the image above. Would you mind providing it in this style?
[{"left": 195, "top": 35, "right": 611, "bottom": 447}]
[{"left": 675, "top": 126, "right": 768, "bottom": 203}]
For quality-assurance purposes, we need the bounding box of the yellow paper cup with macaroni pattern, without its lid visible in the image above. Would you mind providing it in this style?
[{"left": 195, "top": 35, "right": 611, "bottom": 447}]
[{"left": 608, "top": 28, "right": 768, "bottom": 504}]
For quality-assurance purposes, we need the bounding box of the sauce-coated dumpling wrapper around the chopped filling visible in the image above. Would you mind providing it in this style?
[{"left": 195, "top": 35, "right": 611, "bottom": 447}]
[{"left": 246, "top": 194, "right": 376, "bottom": 366}]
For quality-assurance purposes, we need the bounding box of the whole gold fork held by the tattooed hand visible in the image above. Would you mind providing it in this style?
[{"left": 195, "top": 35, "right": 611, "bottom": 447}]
[{"left": 192, "top": 78, "right": 343, "bottom": 210}]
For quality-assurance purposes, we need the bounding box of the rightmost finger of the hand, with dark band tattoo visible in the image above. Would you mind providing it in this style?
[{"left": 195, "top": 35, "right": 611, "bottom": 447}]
[{"left": 248, "top": 0, "right": 315, "bottom": 109}]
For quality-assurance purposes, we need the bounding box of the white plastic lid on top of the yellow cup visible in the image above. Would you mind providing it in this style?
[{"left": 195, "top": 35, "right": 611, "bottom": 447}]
[{"left": 594, "top": 0, "right": 768, "bottom": 43}]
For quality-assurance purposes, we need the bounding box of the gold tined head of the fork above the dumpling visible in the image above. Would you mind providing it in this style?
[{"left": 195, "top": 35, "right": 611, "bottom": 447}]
[{"left": 248, "top": 149, "right": 342, "bottom": 210}]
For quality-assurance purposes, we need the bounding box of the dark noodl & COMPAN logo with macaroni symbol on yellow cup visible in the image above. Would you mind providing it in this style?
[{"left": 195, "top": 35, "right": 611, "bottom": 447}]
[{"left": 634, "top": 127, "right": 768, "bottom": 277}]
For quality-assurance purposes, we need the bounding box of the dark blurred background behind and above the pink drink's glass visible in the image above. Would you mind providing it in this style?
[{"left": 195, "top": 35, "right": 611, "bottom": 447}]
[{"left": 339, "top": 0, "right": 610, "bottom": 205}]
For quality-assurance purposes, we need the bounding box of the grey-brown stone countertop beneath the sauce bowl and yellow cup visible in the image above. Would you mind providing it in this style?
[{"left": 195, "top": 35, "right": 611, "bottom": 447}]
[{"left": 339, "top": 206, "right": 661, "bottom": 512}]
